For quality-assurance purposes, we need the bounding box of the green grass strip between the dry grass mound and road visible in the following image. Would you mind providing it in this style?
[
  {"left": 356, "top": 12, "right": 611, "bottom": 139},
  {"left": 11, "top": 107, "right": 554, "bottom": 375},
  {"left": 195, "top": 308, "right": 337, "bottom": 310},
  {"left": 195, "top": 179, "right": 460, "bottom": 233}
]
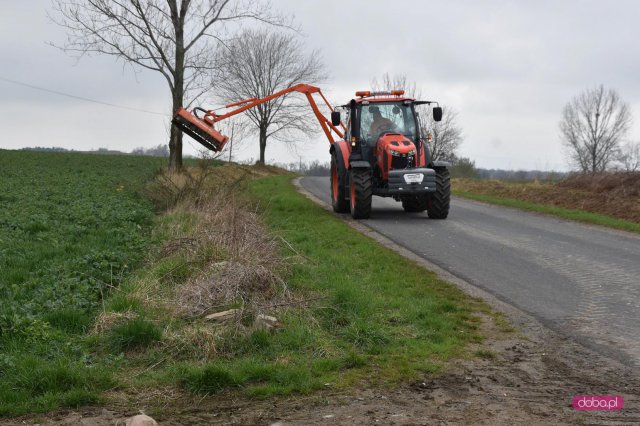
[{"left": 222, "top": 176, "right": 480, "bottom": 392}]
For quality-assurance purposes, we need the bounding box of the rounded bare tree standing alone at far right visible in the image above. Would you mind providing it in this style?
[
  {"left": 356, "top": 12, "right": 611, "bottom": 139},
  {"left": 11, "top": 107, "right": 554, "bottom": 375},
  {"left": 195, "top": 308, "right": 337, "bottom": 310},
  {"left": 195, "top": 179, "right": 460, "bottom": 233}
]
[{"left": 560, "top": 85, "right": 631, "bottom": 173}]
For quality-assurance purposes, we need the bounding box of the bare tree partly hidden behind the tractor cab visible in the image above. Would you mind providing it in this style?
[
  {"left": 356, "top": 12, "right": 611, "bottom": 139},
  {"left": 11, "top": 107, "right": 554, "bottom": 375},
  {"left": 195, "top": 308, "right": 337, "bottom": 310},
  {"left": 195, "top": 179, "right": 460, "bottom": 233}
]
[{"left": 371, "top": 73, "right": 462, "bottom": 161}]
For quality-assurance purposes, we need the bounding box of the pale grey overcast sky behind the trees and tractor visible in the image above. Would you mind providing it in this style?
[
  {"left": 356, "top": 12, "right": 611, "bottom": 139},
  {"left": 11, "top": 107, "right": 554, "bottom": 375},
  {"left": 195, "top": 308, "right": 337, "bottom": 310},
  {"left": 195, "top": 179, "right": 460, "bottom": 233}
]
[{"left": 0, "top": 0, "right": 640, "bottom": 170}]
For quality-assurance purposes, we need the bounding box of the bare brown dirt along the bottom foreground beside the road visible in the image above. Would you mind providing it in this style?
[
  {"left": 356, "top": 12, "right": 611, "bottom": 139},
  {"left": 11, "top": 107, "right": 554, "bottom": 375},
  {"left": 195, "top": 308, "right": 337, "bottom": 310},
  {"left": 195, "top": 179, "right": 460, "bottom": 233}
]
[{"left": 6, "top": 310, "right": 640, "bottom": 426}]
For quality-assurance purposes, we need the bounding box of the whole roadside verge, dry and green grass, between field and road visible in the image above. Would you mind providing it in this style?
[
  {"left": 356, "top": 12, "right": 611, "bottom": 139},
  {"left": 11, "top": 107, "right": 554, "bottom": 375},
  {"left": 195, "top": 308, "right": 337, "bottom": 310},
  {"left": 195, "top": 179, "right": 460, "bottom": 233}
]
[{"left": 92, "top": 166, "right": 487, "bottom": 398}]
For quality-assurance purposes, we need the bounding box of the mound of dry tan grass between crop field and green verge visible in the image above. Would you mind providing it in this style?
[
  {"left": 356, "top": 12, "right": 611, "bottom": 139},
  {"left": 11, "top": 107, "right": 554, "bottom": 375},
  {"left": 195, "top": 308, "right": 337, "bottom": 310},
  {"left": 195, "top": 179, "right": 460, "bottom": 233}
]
[{"left": 94, "top": 164, "right": 292, "bottom": 360}]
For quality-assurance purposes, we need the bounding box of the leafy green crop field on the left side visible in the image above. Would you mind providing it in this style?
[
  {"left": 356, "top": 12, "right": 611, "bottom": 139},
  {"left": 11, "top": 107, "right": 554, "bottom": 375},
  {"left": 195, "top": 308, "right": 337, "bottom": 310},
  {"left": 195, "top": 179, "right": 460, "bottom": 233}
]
[{"left": 0, "top": 150, "right": 161, "bottom": 414}]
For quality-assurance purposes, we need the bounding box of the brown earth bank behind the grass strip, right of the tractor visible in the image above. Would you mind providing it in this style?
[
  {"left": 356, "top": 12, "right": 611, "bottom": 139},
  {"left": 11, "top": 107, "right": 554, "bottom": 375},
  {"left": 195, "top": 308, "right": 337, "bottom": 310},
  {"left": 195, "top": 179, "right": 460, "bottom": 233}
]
[{"left": 453, "top": 172, "right": 640, "bottom": 223}]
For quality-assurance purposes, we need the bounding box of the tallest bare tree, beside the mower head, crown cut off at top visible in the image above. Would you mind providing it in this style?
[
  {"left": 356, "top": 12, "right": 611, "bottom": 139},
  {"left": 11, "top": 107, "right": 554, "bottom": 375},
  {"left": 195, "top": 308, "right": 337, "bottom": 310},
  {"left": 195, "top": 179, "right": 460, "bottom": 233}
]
[{"left": 52, "top": 0, "right": 283, "bottom": 169}]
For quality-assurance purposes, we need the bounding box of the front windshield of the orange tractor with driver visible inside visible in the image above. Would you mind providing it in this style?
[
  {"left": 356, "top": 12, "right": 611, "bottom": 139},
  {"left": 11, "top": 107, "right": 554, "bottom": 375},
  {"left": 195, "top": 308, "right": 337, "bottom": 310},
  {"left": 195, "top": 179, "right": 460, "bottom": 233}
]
[{"left": 360, "top": 102, "right": 417, "bottom": 144}]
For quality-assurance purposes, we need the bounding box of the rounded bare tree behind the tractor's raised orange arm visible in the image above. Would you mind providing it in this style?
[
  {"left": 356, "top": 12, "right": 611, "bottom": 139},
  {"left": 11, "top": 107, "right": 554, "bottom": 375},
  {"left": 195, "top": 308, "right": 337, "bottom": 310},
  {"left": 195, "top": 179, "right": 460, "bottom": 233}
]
[{"left": 215, "top": 30, "right": 326, "bottom": 164}]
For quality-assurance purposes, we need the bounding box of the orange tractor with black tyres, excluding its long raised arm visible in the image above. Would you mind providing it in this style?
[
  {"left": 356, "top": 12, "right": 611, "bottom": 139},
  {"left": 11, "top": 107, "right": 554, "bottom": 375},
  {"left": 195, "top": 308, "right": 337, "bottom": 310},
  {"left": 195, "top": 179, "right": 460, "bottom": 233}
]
[{"left": 330, "top": 90, "right": 449, "bottom": 219}]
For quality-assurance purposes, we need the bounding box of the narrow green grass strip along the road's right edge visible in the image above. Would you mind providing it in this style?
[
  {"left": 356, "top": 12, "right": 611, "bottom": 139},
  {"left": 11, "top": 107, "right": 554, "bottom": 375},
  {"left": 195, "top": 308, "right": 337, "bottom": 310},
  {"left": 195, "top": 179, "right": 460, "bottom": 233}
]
[{"left": 453, "top": 189, "right": 640, "bottom": 233}]
